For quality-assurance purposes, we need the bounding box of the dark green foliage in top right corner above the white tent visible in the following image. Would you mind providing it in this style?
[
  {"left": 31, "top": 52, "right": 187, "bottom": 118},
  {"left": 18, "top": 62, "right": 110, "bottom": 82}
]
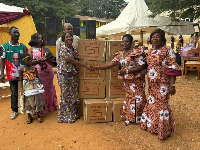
[{"left": 147, "top": 0, "right": 200, "bottom": 20}]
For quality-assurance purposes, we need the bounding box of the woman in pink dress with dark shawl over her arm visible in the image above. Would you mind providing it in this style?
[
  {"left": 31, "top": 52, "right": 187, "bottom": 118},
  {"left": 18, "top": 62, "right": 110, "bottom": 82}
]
[{"left": 28, "top": 33, "right": 58, "bottom": 113}]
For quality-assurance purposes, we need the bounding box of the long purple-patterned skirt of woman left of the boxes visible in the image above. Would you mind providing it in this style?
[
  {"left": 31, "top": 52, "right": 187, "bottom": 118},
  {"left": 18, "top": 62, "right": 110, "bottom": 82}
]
[{"left": 58, "top": 74, "right": 80, "bottom": 123}]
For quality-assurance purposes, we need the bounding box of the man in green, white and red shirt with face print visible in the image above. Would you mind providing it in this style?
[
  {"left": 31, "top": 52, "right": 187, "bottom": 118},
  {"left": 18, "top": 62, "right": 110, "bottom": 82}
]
[{"left": 0, "top": 27, "right": 28, "bottom": 119}]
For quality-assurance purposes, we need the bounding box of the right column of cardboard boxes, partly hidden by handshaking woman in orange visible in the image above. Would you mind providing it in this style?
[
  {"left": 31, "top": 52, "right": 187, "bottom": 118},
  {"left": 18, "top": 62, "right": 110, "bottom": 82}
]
[{"left": 106, "top": 41, "right": 125, "bottom": 122}]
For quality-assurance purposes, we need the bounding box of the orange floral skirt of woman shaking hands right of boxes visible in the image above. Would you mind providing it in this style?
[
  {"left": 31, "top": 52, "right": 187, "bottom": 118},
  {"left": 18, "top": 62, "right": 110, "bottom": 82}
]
[{"left": 122, "top": 78, "right": 146, "bottom": 123}]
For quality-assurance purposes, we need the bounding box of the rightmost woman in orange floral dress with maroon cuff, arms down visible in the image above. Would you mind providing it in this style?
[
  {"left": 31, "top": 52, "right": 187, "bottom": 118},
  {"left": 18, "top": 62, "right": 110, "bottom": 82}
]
[{"left": 141, "top": 29, "right": 181, "bottom": 139}]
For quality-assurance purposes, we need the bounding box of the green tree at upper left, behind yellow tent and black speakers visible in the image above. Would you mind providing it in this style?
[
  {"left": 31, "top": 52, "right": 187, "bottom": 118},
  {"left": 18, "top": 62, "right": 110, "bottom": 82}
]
[{"left": 0, "top": 0, "right": 77, "bottom": 35}]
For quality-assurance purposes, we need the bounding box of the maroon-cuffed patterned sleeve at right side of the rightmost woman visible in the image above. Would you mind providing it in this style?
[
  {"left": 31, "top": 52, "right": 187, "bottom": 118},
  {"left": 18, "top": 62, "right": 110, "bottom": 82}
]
[{"left": 165, "top": 48, "right": 181, "bottom": 76}]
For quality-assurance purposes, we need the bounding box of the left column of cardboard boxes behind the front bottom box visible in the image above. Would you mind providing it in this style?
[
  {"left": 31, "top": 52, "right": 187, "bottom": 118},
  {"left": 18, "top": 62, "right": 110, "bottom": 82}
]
[{"left": 78, "top": 40, "right": 106, "bottom": 120}]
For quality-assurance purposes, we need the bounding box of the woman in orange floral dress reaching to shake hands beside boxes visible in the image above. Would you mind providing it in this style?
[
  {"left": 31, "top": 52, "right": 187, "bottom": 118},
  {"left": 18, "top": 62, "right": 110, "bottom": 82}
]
[{"left": 94, "top": 34, "right": 146, "bottom": 125}]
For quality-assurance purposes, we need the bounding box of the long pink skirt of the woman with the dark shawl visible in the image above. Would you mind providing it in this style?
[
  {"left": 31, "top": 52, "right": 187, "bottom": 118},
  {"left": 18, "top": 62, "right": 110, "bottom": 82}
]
[{"left": 35, "top": 63, "right": 58, "bottom": 113}]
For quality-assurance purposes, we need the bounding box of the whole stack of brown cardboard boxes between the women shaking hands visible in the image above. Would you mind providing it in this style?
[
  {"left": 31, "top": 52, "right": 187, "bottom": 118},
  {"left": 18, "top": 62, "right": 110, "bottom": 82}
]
[{"left": 78, "top": 40, "right": 125, "bottom": 123}]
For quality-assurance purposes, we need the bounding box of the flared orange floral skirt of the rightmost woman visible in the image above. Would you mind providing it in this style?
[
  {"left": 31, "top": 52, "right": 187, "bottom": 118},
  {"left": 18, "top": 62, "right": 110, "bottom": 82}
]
[{"left": 141, "top": 82, "right": 176, "bottom": 139}]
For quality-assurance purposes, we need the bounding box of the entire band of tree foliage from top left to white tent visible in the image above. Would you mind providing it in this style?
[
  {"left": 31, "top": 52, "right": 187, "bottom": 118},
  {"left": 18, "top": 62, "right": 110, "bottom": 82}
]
[{"left": 0, "top": 0, "right": 124, "bottom": 36}]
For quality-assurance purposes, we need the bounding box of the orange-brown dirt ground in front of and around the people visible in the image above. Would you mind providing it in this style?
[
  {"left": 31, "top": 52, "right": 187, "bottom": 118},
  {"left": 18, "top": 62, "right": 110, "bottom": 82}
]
[{"left": 0, "top": 72, "right": 200, "bottom": 150}]
